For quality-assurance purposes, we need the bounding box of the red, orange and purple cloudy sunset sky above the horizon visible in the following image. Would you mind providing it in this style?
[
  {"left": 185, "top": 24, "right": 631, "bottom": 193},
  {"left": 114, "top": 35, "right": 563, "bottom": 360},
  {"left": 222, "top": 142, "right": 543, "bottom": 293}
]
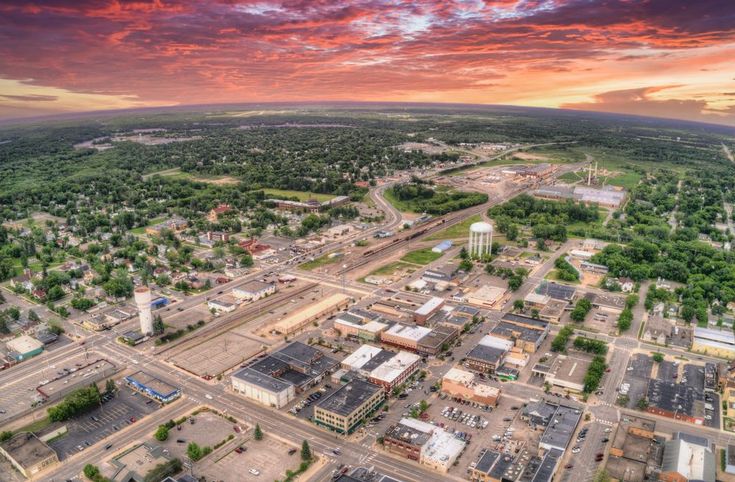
[{"left": 0, "top": 0, "right": 735, "bottom": 125}]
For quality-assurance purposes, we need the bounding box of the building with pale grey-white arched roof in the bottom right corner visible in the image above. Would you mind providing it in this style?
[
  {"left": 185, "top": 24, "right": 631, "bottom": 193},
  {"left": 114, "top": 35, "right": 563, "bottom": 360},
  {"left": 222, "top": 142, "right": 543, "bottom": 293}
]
[{"left": 659, "top": 432, "right": 716, "bottom": 482}]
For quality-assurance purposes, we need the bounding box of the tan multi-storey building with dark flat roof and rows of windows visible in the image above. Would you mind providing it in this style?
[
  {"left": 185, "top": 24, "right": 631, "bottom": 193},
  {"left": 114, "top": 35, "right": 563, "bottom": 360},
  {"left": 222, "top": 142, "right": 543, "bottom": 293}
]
[{"left": 313, "top": 379, "right": 385, "bottom": 434}]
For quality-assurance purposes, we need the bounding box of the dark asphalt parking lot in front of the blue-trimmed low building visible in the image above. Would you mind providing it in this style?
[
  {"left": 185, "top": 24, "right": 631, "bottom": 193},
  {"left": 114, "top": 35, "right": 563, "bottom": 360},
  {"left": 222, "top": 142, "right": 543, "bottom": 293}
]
[{"left": 49, "top": 385, "right": 159, "bottom": 460}]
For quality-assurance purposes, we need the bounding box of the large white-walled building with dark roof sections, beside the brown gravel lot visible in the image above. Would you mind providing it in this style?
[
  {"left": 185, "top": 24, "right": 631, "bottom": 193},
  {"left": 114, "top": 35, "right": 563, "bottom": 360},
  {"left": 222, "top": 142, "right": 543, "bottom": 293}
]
[{"left": 231, "top": 341, "right": 339, "bottom": 408}]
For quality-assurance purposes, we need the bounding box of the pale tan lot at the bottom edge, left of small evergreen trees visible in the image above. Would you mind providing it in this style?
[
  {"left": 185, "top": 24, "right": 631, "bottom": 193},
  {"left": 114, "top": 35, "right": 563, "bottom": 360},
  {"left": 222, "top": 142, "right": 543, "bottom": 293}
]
[{"left": 197, "top": 434, "right": 301, "bottom": 482}]
